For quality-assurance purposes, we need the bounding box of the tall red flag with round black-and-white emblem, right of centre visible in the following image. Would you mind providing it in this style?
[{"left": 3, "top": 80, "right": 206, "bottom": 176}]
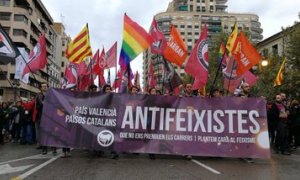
[{"left": 184, "top": 24, "right": 208, "bottom": 90}]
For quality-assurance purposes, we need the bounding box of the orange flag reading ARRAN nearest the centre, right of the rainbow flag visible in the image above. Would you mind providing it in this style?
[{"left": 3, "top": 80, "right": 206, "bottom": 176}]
[{"left": 163, "top": 25, "right": 188, "bottom": 67}]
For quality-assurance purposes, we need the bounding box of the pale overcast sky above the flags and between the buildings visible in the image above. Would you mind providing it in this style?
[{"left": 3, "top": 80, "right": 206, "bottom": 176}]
[{"left": 42, "top": 0, "right": 300, "bottom": 83}]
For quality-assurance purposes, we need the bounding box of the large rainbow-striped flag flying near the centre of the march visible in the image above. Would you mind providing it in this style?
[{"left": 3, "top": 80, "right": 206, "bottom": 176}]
[{"left": 119, "top": 14, "right": 153, "bottom": 68}]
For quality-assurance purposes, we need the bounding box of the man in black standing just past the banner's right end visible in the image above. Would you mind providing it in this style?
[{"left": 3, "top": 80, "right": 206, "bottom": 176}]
[{"left": 270, "top": 94, "right": 291, "bottom": 155}]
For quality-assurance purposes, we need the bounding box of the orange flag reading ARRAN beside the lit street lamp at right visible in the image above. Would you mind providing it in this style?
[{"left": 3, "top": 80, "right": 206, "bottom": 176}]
[{"left": 234, "top": 31, "right": 261, "bottom": 75}]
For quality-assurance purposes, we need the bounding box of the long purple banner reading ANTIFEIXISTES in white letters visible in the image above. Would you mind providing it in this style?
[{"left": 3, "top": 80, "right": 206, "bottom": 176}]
[{"left": 40, "top": 89, "right": 270, "bottom": 158}]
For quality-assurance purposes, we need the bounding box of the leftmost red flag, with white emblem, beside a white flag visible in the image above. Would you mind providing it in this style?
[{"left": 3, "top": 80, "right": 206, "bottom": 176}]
[{"left": 22, "top": 34, "right": 47, "bottom": 78}]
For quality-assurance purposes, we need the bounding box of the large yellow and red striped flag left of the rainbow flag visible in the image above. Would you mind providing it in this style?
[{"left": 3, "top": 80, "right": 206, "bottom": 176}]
[{"left": 66, "top": 24, "right": 92, "bottom": 63}]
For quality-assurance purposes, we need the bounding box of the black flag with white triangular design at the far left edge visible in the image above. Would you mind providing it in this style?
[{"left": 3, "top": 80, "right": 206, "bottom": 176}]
[{"left": 0, "top": 25, "right": 20, "bottom": 64}]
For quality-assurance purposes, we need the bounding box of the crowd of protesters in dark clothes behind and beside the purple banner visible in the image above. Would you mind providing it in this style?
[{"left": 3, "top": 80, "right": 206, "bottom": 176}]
[{"left": 0, "top": 83, "right": 300, "bottom": 159}]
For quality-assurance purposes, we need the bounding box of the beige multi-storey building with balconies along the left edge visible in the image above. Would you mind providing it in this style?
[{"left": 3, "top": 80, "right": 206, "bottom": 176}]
[{"left": 0, "top": 0, "right": 62, "bottom": 101}]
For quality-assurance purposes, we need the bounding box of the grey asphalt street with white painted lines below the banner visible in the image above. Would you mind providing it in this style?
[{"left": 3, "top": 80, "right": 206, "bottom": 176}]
[{"left": 0, "top": 143, "right": 300, "bottom": 180}]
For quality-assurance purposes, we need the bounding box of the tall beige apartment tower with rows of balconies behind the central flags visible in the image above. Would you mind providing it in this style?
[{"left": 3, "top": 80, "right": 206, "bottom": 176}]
[{"left": 143, "top": 0, "right": 263, "bottom": 90}]
